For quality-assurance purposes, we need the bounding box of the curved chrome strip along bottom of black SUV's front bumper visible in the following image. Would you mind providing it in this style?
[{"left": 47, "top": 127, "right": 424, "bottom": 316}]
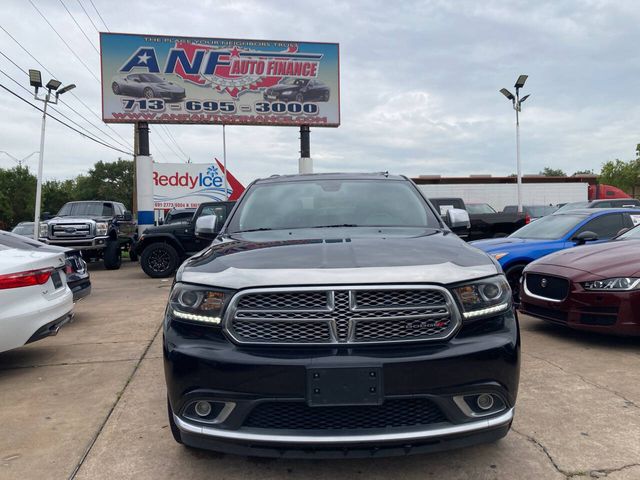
[{"left": 173, "top": 408, "right": 514, "bottom": 445}]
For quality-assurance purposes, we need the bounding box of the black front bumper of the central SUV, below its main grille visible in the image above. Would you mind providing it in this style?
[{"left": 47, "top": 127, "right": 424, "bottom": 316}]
[{"left": 164, "top": 312, "right": 520, "bottom": 457}]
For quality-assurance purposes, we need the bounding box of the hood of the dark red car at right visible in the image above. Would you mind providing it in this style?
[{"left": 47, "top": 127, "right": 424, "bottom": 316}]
[{"left": 536, "top": 240, "right": 640, "bottom": 278}]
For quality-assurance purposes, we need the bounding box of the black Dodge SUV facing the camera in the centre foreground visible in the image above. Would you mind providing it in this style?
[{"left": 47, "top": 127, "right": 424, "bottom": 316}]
[{"left": 163, "top": 174, "right": 520, "bottom": 458}]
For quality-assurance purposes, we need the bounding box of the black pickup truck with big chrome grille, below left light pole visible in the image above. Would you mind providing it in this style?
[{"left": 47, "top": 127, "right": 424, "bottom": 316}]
[{"left": 38, "top": 200, "right": 136, "bottom": 270}]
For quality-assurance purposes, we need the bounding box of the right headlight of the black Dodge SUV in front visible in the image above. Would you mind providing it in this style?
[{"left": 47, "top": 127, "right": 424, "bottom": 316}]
[{"left": 453, "top": 275, "right": 511, "bottom": 319}]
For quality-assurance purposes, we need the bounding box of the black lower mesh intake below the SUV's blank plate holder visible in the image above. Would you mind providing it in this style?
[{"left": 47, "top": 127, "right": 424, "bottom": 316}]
[{"left": 244, "top": 398, "right": 447, "bottom": 431}]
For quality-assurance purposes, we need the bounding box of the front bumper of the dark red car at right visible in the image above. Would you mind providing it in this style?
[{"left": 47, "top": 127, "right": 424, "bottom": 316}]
[{"left": 520, "top": 265, "right": 640, "bottom": 336}]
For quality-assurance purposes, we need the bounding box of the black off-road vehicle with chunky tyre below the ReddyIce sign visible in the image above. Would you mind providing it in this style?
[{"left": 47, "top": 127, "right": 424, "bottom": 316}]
[{"left": 134, "top": 202, "right": 235, "bottom": 278}]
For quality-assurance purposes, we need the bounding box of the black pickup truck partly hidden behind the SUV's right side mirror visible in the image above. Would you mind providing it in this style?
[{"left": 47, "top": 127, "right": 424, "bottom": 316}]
[{"left": 429, "top": 198, "right": 528, "bottom": 241}]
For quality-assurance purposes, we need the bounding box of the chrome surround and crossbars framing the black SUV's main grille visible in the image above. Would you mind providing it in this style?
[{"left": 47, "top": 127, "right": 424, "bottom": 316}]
[{"left": 222, "top": 284, "right": 462, "bottom": 347}]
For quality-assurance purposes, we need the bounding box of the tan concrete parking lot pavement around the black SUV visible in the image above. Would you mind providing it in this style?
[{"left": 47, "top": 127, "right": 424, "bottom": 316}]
[{"left": 0, "top": 262, "right": 640, "bottom": 480}]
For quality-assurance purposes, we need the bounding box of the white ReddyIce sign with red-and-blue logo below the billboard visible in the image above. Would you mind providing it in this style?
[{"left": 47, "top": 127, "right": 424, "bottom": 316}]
[{"left": 153, "top": 159, "right": 244, "bottom": 209}]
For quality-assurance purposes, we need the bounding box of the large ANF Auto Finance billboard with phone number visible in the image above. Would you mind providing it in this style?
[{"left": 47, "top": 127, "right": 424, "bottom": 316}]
[{"left": 100, "top": 33, "right": 340, "bottom": 127}]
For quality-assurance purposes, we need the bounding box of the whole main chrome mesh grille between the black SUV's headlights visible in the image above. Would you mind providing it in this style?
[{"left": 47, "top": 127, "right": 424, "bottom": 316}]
[{"left": 225, "top": 286, "right": 460, "bottom": 345}]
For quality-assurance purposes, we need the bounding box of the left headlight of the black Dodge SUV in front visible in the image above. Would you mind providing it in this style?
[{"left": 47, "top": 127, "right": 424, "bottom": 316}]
[{"left": 169, "top": 283, "right": 225, "bottom": 325}]
